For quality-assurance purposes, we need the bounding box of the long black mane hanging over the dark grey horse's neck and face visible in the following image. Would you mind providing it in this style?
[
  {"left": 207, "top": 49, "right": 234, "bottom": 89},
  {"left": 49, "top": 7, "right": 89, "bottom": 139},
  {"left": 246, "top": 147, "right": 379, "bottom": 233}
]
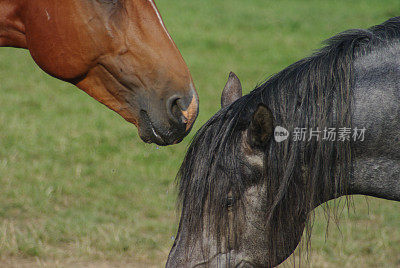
[{"left": 177, "top": 17, "right": 400, "bottom": 255}]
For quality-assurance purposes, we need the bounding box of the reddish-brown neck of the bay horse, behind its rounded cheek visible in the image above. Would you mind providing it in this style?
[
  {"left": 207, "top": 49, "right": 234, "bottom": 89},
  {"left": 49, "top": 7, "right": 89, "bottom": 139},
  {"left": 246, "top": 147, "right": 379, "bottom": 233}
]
[{"left": 0, "top": 0, "right": 27, "bottom": 48}]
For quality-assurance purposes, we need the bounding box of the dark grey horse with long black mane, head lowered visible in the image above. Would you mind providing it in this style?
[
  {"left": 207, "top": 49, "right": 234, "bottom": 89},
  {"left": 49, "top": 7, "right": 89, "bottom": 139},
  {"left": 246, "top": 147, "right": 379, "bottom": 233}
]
[{"left": 167, "top": 17, "right": 400, "bottom": 267}]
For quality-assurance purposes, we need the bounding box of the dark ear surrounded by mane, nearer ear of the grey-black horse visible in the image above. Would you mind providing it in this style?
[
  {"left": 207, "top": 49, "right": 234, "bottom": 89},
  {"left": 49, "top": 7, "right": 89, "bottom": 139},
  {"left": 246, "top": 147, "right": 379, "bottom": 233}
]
[{"left": 247, "top": 104, "right": 273, "bottom": 149}]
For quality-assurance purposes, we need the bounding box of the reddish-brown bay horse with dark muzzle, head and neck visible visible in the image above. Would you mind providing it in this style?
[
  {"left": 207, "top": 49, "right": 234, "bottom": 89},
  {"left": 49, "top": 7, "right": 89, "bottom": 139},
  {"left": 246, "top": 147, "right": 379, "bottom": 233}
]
[{"left": 0, "top": 0, "right": 198, "bottom": 145}]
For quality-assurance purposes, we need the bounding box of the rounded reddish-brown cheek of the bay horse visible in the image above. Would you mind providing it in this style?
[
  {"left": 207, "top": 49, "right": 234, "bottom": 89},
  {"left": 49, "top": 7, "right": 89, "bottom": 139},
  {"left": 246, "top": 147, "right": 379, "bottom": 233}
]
[{"left": 25, "top": 2, "right": 98, "bottom": 81}]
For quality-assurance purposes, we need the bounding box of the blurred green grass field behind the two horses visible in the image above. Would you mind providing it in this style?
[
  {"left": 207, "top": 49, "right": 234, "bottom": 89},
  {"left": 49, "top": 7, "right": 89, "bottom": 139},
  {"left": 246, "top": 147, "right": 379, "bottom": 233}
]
[{"left": 0, "top": 0, "right": 400, "bottom": 267}]
